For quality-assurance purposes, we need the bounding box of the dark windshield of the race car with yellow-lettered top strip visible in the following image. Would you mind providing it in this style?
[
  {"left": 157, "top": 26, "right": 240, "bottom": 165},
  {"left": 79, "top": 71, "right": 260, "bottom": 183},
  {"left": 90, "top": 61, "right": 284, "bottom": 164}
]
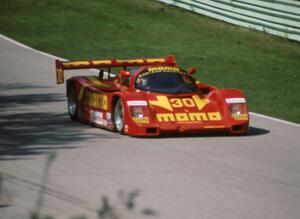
[{"left": 135, "top": 67, "right": 197, "bottom": 94}]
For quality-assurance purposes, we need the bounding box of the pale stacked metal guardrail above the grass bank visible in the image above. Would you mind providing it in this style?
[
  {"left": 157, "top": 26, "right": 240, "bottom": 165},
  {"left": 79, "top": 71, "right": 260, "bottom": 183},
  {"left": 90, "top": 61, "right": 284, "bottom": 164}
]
[{"left": 158, "top": 0, "right": 300, "bottom": 42}]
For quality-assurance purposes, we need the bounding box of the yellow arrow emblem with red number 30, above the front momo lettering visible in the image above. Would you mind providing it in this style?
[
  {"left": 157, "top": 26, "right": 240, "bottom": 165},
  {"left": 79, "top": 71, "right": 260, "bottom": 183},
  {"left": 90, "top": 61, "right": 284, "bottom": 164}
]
[{"left": 149, "top": 95, "right": 209, "bottom": 111}]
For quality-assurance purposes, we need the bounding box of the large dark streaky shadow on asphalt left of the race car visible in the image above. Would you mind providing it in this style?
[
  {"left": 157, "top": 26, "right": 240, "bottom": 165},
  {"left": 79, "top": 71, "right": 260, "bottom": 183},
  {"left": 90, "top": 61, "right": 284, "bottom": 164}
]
[{"left": 0, "top": 84, "right": 114, "bottom": 161}]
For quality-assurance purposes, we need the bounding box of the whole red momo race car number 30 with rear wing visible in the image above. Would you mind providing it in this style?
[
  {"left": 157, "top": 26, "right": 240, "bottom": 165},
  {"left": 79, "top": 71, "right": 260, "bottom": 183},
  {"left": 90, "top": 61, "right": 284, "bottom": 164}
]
[{"left": 56, "top": 55, "right": 249, "bottom": 136}]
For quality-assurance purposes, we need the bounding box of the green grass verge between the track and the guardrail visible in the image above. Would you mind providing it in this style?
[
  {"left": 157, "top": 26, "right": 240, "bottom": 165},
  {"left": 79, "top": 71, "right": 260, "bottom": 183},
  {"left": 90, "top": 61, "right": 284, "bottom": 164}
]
[{"left": 0, "top": 0, "right": 300, "bottom": 123}]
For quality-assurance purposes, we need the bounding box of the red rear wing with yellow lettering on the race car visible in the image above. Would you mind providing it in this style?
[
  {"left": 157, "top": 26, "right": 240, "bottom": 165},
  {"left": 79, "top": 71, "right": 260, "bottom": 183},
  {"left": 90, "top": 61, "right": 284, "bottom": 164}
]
[{"left": 55, "top": 55, "right": 176, "bottom": 84}]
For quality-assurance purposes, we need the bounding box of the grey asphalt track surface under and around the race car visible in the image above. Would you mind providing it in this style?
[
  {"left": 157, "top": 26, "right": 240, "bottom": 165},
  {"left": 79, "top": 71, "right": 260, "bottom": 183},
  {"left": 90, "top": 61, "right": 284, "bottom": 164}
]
[{"left": 0, "top": 37, "right": 300, "bottom": 219}]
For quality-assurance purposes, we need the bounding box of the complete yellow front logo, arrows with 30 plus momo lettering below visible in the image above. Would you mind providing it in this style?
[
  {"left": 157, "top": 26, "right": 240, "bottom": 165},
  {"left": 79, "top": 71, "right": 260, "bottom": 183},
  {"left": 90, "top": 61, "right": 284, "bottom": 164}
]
[{"left": 149, "top": 95, "right": 222, "bottom": 122}]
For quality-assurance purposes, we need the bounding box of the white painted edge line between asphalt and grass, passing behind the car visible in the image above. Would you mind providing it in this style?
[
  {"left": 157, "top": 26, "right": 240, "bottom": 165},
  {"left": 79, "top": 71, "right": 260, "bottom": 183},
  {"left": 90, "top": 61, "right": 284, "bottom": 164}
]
[{"left": 0, "top": 33, "right": 300, "bottom": 127}]
